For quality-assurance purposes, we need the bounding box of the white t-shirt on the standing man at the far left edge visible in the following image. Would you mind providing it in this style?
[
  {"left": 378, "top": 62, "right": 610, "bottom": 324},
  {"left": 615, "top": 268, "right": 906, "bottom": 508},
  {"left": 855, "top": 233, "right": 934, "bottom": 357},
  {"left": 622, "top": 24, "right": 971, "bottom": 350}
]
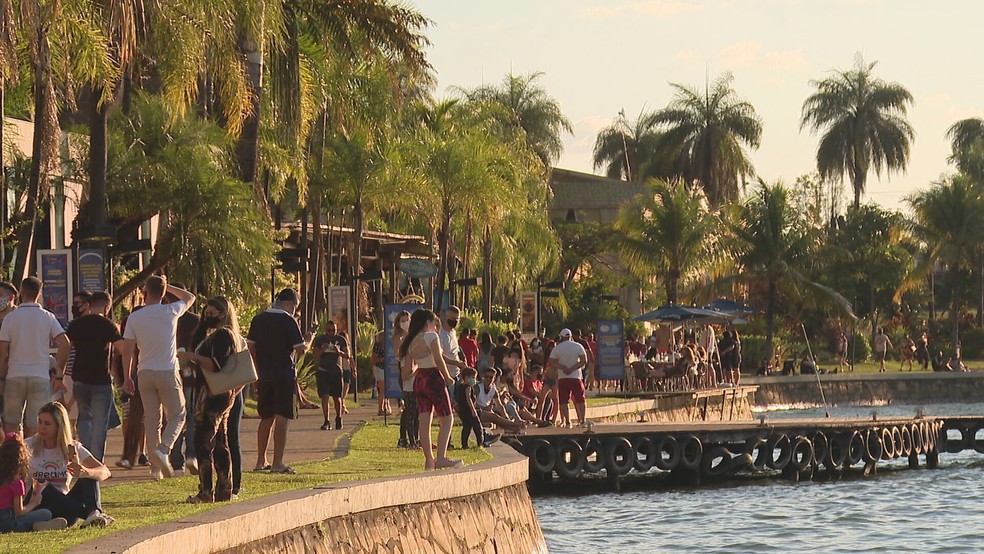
[{"left": 0, "top": 302, "right": 65, "bottom": 379}]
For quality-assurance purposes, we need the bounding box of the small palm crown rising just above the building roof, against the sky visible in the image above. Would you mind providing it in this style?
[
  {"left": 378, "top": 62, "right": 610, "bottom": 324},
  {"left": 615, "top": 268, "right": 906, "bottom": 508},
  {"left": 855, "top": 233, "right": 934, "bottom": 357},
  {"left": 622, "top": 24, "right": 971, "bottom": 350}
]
[{"left": 593, "top": 111, "right": 665, "bottom": 182}]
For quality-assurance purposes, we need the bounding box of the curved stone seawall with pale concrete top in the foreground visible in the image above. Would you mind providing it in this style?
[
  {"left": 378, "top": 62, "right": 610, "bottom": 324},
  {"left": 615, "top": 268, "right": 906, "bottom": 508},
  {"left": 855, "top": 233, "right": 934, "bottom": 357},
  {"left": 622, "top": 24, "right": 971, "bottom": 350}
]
[{"left": 69, "top": 445, "right": 546, "bottom": 554}]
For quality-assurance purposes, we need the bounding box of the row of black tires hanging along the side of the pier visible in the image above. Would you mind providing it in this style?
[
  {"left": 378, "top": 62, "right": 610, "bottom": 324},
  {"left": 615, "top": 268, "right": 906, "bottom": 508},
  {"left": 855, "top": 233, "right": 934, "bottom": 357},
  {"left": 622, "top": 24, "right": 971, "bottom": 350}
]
[{"left": 526, "top": 422, "right": 940, "bottom": 478}]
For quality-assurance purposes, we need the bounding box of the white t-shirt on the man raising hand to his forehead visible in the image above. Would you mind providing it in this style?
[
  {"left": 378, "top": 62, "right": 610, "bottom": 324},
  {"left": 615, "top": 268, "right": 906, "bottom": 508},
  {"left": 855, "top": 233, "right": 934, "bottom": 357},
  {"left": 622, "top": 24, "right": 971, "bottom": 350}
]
[{"left": 123, "top": 300, "right": 191, "bottom": 371}]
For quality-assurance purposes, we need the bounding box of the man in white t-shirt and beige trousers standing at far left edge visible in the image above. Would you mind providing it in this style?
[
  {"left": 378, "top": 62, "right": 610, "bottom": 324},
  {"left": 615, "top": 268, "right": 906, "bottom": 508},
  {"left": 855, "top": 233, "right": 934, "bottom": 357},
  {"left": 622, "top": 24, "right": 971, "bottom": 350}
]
[{"left": 0, "top": 277, "right": 71, "bottom": 437}]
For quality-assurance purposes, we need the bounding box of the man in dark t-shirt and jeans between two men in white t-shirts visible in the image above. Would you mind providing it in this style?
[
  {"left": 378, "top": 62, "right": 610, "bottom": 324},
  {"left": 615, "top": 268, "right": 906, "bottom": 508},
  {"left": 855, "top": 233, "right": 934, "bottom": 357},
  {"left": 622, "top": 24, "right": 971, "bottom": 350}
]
[{"left": 67, "top": 291, "right": 123, "bottom": 461}]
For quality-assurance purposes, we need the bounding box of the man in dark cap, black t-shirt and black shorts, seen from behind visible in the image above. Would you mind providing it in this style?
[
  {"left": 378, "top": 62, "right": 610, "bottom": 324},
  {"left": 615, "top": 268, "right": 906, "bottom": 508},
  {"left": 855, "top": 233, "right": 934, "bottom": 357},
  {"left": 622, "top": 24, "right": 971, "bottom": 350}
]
[{"left": 246, "top": 289, "right": 307, "bottom": 473}]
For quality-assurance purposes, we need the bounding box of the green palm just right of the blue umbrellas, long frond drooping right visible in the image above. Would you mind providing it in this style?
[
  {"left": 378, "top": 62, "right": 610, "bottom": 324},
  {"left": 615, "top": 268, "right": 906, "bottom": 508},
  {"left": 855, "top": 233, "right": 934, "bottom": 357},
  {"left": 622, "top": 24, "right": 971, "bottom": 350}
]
[{"left": 716, "top": 180, "right": 853, "bottom": 360}]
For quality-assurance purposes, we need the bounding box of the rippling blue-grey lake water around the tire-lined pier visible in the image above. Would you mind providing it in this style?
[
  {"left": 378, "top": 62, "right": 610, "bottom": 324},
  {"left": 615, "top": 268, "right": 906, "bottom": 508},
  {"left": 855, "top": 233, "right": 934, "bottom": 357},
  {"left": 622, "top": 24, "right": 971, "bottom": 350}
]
[{"left": 533, "top": 404, "right": 984, "bottom": 553}]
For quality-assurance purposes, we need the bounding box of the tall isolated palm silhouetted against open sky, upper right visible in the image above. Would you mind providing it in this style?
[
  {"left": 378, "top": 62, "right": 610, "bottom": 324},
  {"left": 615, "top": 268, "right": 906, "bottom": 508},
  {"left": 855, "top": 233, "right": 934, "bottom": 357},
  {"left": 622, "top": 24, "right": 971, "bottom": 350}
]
[{"left": 800, "top": 56, "right": 915, "bottom": 208}]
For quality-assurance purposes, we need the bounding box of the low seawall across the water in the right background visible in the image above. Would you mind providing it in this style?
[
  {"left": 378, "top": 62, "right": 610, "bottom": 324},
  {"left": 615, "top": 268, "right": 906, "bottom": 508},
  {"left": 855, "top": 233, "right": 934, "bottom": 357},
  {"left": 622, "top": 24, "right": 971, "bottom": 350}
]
[{"left": 742, "top": 371, "right": 984, "bottom": 409}]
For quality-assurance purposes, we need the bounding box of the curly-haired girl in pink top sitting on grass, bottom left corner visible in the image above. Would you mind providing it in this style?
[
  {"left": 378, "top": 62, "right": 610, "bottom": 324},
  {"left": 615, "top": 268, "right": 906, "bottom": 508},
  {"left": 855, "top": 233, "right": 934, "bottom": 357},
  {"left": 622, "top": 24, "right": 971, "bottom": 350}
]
[{"left": 0, "top": 433, "right": 68, "bottom": 533}]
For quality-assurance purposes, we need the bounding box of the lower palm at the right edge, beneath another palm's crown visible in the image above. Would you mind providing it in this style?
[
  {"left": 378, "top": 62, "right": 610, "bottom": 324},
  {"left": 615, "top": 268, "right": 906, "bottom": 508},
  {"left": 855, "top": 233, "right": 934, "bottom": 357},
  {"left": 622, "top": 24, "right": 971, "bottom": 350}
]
[{"left": 896, "top": 175, "right": 984, "bottom": 352}]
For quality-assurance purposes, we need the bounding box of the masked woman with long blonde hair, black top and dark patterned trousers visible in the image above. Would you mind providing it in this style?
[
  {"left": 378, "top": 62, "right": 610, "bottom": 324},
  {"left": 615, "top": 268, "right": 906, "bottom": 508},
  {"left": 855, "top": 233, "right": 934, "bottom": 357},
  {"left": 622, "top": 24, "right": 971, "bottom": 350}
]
[{"left": 178, "top": 296, "right": 246, "bottom": 504}]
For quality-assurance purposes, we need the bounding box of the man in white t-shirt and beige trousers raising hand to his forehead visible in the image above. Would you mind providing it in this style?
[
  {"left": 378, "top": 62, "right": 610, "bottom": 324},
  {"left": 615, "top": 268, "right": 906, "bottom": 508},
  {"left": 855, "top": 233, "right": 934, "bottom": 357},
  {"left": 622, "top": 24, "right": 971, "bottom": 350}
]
[{"left": 121, "top": 276, "right": 195, "bottom": 479}]
